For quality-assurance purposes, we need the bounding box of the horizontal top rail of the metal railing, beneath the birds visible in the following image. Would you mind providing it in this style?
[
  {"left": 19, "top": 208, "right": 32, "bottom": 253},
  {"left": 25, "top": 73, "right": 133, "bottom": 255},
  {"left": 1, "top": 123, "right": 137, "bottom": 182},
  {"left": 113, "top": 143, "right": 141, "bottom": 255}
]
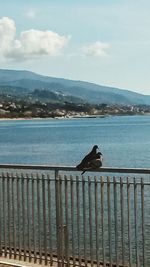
[{"left": 0, "top": 164, "right": 150, "bottom": 174}]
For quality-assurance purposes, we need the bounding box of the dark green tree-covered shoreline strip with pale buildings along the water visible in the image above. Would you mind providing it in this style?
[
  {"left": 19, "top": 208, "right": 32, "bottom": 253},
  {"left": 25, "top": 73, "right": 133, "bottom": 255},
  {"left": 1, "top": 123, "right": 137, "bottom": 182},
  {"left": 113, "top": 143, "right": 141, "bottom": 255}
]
[{"left": 0, "top": 98, "right": 150, "bottom": 119}]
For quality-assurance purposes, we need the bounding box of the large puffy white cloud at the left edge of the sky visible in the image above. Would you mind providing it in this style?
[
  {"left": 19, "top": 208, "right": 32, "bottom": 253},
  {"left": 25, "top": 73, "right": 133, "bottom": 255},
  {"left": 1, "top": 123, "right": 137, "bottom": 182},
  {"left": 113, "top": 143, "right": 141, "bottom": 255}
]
[{"left": 0, "top": 17, "right": 70, "bottom": 60}]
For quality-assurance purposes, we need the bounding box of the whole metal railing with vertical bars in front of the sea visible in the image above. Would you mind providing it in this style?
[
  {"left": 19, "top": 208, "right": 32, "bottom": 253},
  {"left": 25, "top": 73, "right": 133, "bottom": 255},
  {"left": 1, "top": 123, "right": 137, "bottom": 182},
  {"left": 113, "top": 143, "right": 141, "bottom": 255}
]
[{"left": 0, "top": 164, "right": 150, "bottom": 267}]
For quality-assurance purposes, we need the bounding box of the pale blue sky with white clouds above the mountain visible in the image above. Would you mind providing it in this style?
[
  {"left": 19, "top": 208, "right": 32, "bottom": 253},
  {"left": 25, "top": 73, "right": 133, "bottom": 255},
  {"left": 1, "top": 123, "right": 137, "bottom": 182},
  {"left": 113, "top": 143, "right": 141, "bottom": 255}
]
[{"left": 0, "top": 0, "right": 150, "bottom": 95}]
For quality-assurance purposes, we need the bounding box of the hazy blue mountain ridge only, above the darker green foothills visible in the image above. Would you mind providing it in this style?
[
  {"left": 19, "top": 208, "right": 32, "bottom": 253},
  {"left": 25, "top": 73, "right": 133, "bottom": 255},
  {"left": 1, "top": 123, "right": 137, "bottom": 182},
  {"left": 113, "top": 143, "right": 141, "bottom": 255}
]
[{"left": 0, "top": 69, "right": 150, "bottom": 105}]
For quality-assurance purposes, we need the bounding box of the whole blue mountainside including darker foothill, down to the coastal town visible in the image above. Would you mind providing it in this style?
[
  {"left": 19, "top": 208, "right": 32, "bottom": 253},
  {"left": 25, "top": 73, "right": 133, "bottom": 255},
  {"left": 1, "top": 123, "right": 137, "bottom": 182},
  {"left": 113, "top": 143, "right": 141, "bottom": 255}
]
[{"left": 0, "top": 69, "right": 150, "bottom": 105}]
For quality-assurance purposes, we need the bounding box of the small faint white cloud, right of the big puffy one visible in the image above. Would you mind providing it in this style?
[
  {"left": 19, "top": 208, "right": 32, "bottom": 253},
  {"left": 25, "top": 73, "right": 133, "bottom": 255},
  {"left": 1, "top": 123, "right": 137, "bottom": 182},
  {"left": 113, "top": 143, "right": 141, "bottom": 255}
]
[{"left": 82, "top": 41, "right": 110, "bottom": 57}]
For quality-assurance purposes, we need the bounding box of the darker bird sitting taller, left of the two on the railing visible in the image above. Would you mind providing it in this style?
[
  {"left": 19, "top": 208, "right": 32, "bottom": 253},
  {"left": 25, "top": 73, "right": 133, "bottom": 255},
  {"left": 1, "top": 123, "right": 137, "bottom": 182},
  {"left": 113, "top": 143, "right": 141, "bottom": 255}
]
[{"left": 76, "top": 145, "right": 98, "bottom": 171}]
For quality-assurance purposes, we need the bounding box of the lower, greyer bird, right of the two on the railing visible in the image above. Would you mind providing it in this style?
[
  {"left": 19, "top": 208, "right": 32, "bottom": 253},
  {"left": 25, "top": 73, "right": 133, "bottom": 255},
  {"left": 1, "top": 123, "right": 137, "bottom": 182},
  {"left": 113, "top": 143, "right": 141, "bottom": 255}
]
[{"left": 81, "top": 152, "right": 103, "bottom": 175}]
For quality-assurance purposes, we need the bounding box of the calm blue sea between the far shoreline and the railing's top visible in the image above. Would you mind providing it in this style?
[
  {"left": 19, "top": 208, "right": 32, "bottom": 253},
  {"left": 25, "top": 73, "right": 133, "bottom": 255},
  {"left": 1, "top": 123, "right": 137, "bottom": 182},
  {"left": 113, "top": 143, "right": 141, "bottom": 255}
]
[{"left": 0, "top": 116, "right": 150, "bottom": 168}]
